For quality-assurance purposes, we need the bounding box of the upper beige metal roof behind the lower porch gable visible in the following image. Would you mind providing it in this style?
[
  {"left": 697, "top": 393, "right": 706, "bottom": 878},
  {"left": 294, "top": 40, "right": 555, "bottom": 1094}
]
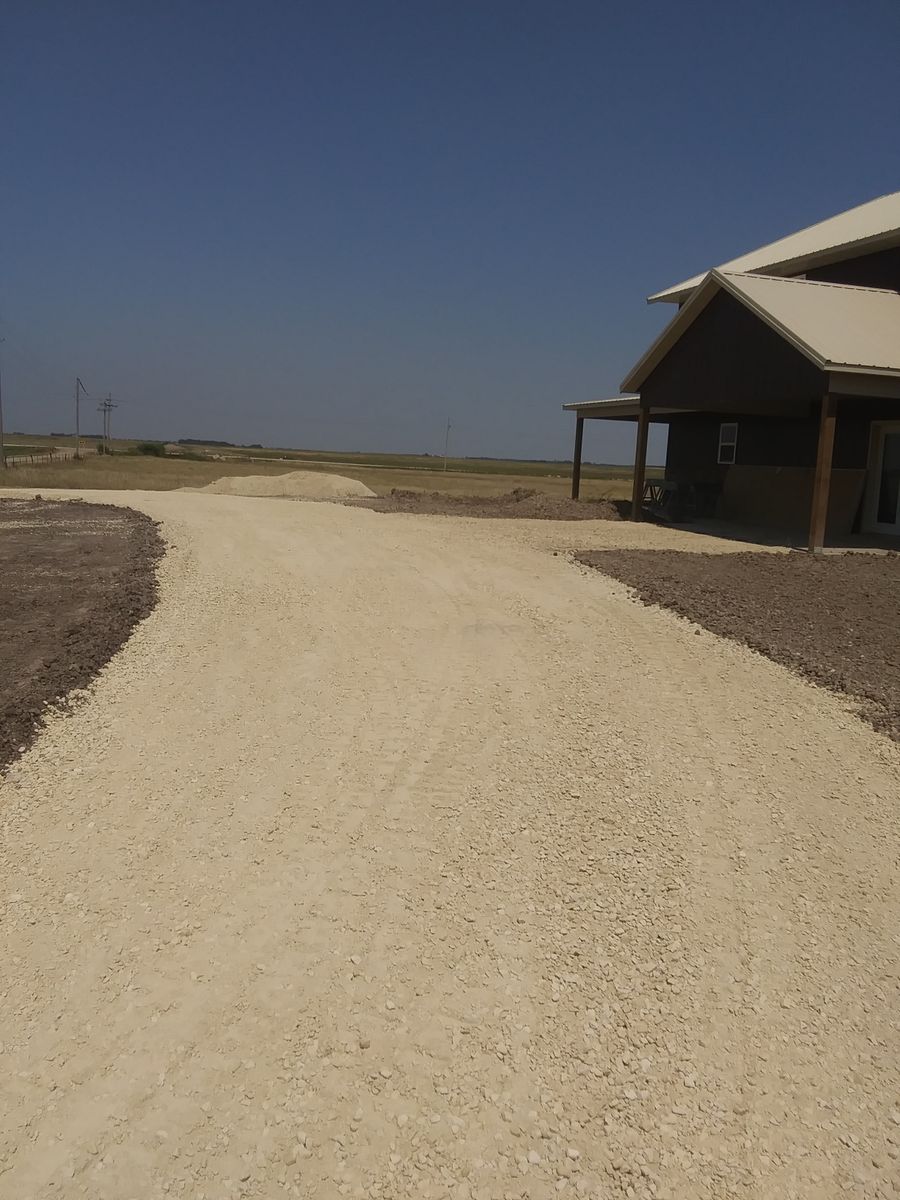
[{"left": 648, "top": 192, "right": 900, "bottom": 304}]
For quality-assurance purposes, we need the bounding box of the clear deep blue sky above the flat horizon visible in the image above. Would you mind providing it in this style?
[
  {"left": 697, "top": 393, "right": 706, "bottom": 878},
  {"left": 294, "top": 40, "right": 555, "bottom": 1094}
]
[{"left": 0, "top": 0, "right": 900, "bottom": 461}]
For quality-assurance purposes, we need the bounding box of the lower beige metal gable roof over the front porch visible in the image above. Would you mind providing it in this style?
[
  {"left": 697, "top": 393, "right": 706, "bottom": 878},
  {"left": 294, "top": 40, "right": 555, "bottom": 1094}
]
[{"left": 622, "top": 270, "right": 900, "bottom": 391}]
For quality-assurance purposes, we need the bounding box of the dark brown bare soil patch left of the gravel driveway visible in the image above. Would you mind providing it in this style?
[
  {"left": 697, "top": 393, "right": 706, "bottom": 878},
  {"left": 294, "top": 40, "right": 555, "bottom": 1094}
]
[{"left": 0, "top": 499, "right": 164, "bottom": 767}]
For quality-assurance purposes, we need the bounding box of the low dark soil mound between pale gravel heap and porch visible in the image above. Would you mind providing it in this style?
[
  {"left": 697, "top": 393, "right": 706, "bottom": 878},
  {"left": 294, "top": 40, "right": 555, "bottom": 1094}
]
[{"left": 352, "top": 487, "right": 623, "bottom": 521}]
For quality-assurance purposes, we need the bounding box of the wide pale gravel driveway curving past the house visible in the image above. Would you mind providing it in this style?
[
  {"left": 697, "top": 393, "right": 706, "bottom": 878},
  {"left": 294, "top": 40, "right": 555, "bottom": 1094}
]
[{"left": 0, "top": 493, "right": 900, "bottom": 1200}]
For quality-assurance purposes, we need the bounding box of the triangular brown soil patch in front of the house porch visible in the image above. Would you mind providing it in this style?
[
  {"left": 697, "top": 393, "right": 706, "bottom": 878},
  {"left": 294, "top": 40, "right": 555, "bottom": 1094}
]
[{"left": 576, "top": 550, "right": 900, "bottom": 740}]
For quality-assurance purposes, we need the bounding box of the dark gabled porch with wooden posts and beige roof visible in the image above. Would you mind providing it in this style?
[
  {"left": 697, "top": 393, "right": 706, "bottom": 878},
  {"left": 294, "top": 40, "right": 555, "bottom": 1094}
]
[{"left": 563, "top": 272, "right": 900, "bottom": 553}]
